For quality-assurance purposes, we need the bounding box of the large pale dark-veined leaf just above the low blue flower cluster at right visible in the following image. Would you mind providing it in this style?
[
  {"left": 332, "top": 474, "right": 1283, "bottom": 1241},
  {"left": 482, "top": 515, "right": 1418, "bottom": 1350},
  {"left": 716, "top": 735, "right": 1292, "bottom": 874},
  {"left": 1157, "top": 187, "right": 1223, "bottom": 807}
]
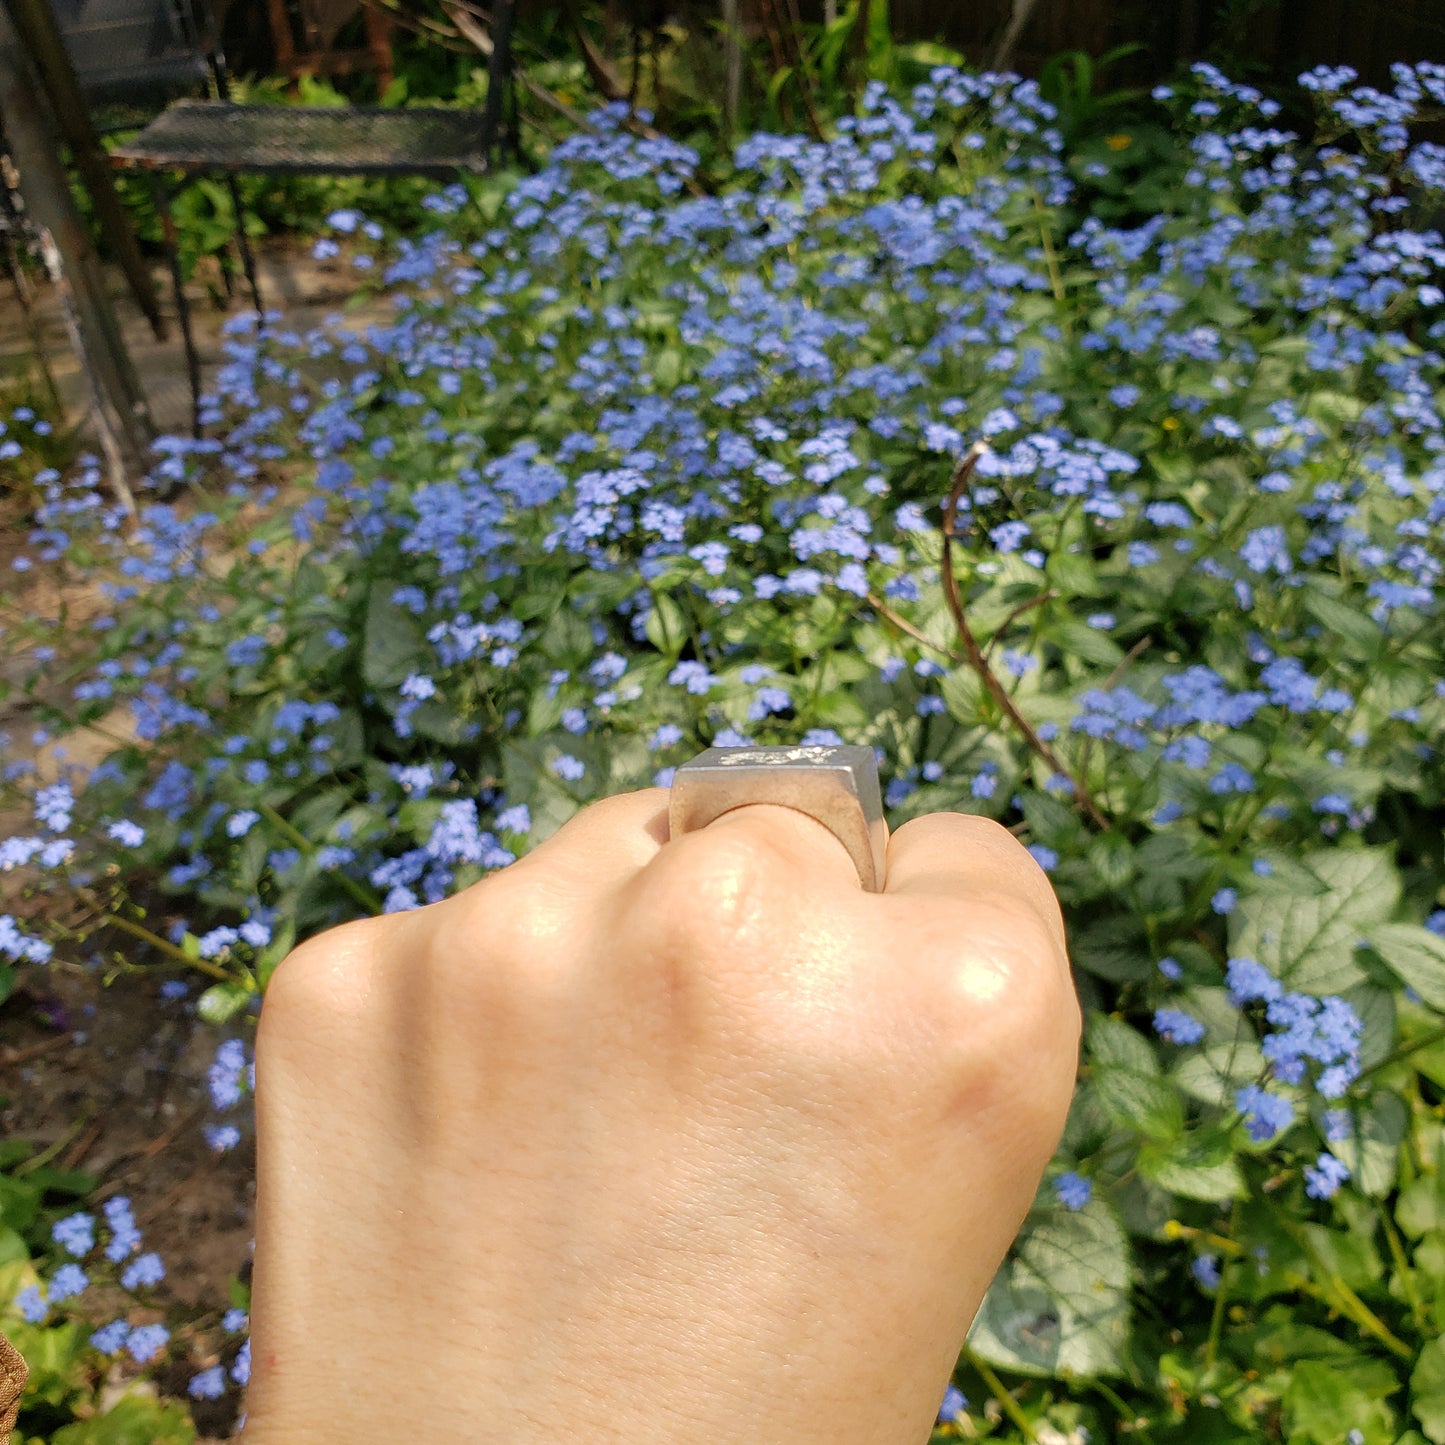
[{"left": 1230, "top": 848, "right": 1400, "bottom": 994}]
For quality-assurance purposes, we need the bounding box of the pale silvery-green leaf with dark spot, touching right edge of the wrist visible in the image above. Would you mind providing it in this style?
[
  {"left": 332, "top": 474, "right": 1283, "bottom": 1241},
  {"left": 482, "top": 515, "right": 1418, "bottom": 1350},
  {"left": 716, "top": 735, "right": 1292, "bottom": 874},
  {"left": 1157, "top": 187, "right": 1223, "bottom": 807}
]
[{"left": 968, "top": 1201, "right": 1130, "bottom": 1379}]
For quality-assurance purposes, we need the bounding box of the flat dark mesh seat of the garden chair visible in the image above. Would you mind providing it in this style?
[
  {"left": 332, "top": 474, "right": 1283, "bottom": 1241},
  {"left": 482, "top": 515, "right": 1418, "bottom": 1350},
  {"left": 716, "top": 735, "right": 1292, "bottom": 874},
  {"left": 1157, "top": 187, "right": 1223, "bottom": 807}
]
[{"left": 111, "top": 100, "right": 487, "bottom": 178}]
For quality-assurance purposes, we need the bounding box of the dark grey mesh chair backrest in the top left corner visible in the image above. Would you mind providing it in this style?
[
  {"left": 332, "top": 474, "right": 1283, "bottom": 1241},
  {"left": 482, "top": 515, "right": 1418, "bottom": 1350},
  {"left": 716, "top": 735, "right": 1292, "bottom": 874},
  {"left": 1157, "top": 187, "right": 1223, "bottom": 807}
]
[{"left": 51, "top": 0, "right": 211, "bottom": 107}]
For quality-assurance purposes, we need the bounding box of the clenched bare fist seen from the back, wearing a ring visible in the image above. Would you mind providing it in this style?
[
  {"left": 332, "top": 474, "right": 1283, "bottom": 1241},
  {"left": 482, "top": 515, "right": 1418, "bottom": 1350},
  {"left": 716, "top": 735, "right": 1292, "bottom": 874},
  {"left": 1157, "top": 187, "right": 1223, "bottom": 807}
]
[{"left": 236, "top": 789, "right": 1079, "bottom": 1445}]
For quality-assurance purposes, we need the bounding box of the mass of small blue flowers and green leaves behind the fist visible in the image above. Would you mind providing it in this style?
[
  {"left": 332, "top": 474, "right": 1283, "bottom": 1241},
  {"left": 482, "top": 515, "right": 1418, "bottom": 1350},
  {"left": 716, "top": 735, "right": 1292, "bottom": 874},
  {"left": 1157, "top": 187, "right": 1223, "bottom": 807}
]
[{"left": 0, "top": 52, "right": 1445, "bottom": 1445}]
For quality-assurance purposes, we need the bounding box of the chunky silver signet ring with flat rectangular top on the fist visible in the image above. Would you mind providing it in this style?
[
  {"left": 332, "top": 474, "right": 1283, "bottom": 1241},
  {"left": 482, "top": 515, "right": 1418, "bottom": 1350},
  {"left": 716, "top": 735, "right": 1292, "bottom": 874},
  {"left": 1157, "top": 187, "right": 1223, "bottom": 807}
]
[{"left": 668, "top": 747, "right": 889, "bottom": 893}]
